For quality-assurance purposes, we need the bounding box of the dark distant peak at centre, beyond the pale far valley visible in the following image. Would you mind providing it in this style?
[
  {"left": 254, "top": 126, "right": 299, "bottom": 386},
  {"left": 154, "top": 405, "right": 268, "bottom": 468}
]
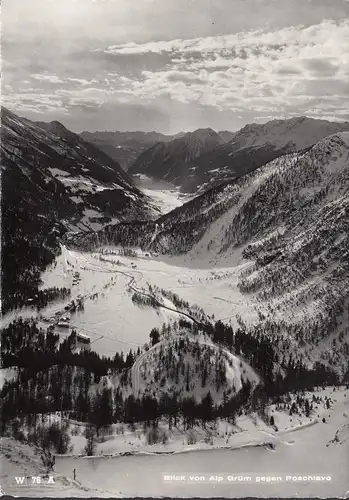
[{"left": 129, "top": 129, "right": 224, "bottom": 185}]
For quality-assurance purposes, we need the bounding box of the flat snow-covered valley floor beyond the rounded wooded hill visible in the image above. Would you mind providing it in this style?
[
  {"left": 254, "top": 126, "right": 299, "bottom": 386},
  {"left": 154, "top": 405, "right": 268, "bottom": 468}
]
[{"left": 2, "top": 247, "right": 257, "bottom": 356}]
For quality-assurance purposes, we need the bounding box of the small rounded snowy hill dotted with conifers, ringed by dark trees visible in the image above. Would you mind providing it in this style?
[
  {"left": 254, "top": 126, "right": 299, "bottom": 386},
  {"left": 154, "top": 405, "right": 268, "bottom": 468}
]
[{"left": 133, "top": 332, "right": 258, "bottom": 404}]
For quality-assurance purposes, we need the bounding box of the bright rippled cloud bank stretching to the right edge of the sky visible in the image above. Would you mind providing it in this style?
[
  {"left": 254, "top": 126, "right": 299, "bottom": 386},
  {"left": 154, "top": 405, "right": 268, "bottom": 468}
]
[{"left": 98, "top": 21, "right": 349, "bottom": 112}]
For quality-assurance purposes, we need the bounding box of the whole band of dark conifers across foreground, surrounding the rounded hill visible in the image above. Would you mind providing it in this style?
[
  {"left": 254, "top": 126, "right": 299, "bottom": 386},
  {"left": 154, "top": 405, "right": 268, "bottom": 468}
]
[{"left": 0, "top": 319, "right": 342, "bottom": 442}]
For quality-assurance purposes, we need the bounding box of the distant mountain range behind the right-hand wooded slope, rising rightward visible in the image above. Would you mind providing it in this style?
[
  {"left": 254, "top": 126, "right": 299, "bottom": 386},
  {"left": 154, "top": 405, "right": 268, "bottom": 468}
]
[{"left": 125, "top": 117, "right": 349, "bottom": 193}]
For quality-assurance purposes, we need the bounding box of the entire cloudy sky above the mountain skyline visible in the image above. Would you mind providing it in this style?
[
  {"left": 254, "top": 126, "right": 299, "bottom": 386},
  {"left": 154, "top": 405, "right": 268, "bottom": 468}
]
[{"left": 2, "top": 0, "right": 349, "bottom": 133}]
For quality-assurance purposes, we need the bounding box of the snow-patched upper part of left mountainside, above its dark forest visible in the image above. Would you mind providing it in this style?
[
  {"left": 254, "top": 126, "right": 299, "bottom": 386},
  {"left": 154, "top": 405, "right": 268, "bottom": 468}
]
[{"left": 2, "top": 108, "right": 154, "bottom": 229}]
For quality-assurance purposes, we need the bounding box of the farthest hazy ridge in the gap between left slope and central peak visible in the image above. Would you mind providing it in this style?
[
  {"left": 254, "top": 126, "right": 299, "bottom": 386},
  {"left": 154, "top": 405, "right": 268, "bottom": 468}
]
[{"left": 80, "top": 131, "right": 181, "bottom": 171}]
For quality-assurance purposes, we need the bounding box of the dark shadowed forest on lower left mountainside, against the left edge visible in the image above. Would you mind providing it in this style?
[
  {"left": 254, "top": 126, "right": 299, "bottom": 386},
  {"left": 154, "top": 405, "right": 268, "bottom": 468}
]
[{"left": 1, "top": 159, "right": 73, "bottom": 314}]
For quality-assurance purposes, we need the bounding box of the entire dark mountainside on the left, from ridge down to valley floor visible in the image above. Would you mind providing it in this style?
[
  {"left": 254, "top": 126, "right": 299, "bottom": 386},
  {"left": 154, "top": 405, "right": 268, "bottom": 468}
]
[{"left": 1, "top": 108, "right": 152, "bottom": 310}]
